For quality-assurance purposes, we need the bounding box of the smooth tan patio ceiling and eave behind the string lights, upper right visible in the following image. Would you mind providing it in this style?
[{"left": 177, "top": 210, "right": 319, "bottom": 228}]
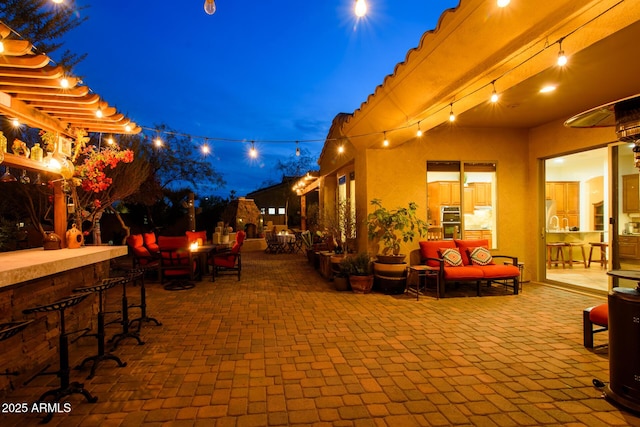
[{"left": 336, "top": 0, "right": 640, "bottom": 148}]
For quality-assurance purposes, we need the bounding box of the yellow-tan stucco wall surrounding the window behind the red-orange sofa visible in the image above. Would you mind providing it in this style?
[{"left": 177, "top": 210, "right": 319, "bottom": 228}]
[{"left": 356, "top": 126, "right": 532, "bottom": 263}]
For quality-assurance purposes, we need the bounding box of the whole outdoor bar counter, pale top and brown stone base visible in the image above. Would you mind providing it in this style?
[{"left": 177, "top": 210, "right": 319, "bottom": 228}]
[{"left": 0, "top": 246, "right": 127, "bottom": 397}]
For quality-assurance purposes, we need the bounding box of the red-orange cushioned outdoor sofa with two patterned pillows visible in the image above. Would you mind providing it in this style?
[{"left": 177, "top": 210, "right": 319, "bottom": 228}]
[{"left": 419, "top": 239, "right": 520, "bottom": 296}]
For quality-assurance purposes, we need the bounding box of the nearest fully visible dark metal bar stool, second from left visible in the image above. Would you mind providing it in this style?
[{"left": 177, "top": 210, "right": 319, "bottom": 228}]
[{"left": 23, "top": 293, "right": 98, "bottom": 423}]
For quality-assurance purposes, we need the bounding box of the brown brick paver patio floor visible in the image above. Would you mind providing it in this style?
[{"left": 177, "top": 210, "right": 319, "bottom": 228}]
[{"left": 0, "top": 252, "right": 640, "bottom": 427}]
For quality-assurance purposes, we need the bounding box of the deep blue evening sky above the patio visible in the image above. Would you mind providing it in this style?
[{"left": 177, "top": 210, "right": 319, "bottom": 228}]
[{"left": 60, "top": 0, "right": 458, "bottom": 197}]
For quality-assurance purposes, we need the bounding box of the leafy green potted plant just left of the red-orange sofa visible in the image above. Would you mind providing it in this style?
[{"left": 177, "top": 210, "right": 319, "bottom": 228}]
[{"left": 367, "top": 199, "right": 428, "bottom": 263}]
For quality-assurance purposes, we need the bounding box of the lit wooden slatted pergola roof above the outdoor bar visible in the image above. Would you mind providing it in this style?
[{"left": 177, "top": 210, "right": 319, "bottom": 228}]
[{"left": 0, "top": 23, "right": 141, "bottom": 137}]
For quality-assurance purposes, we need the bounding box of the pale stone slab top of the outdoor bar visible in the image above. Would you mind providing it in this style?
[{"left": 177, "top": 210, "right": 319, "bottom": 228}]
[{"left": 0, "top": 246, "right": 127, "bottom": 288}]
